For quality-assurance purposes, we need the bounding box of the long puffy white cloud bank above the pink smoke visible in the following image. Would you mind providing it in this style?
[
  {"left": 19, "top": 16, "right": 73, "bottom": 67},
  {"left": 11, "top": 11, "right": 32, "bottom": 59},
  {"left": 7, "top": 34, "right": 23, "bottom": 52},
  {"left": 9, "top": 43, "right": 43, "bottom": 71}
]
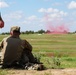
[{"left": 38, "top": 8, "right": 68, "bottom": 18}]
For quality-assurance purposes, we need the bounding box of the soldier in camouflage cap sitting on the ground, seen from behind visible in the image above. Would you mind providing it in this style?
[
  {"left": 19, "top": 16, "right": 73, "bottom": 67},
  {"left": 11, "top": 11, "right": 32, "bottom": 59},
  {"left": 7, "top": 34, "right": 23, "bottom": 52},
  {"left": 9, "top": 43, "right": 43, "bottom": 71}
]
[{"left": 0, "top": 26, "right": 35, "bottom": 68}]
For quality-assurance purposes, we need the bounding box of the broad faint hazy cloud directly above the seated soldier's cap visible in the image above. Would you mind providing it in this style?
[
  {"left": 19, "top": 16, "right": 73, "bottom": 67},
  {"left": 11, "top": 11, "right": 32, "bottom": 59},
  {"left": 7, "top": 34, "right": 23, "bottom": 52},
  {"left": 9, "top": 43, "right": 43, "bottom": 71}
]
[{"left": 3, "top": 11, "right": 24, "bottom": 24}]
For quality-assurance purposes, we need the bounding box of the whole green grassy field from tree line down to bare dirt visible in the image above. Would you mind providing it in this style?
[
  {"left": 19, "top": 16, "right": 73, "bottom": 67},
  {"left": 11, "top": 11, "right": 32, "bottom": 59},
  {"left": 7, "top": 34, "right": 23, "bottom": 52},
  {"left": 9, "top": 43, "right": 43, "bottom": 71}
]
[{"left": 0, "top": 34, "right": 76, "bottom": 68}]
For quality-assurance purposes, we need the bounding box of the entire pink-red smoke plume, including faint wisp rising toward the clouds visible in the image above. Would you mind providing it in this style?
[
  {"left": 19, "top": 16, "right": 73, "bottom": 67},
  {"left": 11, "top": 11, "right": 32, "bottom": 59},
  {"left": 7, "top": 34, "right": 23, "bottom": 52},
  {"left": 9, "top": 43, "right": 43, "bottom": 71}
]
[{"left": 45, "top": 14, "right": 69, "bottom": 34}]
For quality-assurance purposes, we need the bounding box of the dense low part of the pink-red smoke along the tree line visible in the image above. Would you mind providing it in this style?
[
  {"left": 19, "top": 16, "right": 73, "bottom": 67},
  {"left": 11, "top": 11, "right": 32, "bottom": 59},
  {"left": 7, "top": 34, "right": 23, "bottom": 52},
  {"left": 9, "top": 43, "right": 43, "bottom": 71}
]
[{"left": 47, "top": 24, "right": 69, "bottom": 34}]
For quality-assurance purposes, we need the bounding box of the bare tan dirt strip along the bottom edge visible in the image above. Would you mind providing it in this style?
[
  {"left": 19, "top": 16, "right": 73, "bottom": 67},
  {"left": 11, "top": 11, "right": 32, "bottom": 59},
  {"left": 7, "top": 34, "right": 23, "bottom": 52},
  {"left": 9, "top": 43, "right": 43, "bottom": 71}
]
[{"left": 7, "top": 69, "right": 76, "bottom": 75}]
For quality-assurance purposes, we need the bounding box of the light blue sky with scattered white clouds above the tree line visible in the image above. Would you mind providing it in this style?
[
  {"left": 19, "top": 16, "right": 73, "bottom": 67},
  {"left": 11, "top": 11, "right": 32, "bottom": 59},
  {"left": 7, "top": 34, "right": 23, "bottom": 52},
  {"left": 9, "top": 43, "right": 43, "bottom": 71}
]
[{"left": 0, "top": 0, "right": 76, "bottom": 32}]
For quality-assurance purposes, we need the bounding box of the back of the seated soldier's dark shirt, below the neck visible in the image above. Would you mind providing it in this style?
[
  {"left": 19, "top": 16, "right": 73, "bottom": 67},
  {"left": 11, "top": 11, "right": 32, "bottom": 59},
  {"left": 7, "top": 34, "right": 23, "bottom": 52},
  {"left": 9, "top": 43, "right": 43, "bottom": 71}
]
[{"left": 3, "top": 37, "right": 23, "bottom": 64}]
